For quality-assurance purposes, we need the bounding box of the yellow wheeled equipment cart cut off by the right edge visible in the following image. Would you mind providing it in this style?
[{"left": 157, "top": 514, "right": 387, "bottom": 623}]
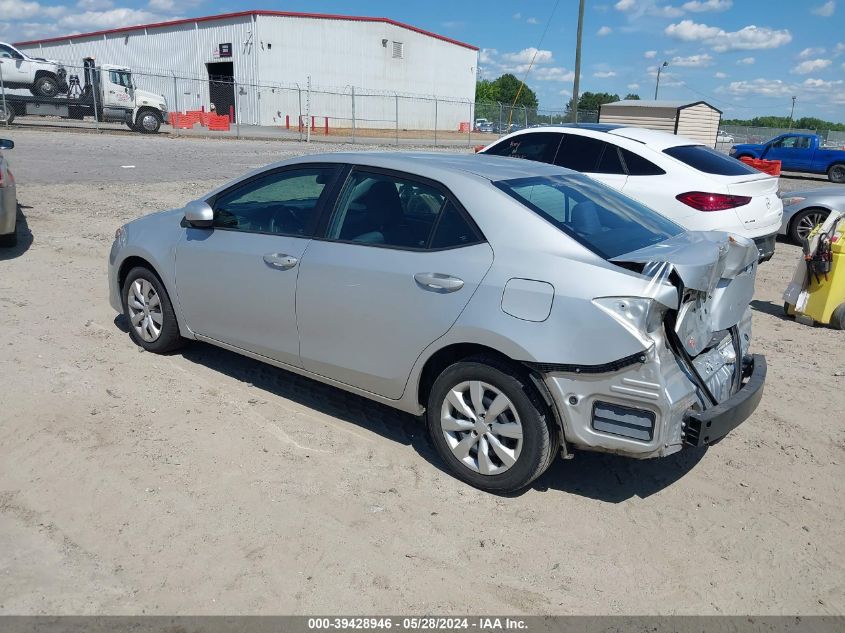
[{"left": 784, "top": 214, "right": 845, "bottom": 330}]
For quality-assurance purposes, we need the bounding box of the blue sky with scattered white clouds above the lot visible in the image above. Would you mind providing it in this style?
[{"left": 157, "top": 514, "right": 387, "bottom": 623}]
[{"left": 0, "top": 0, "right": 845, "bottom": 122}]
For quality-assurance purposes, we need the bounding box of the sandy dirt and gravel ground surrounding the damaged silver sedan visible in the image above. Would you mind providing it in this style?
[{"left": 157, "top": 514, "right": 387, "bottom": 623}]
[{"left": 0, "top": 131, "right": 845, "bottom": 614}]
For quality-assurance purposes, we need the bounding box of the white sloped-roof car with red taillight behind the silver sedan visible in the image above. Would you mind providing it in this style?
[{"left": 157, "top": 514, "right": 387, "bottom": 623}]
[{"left": 480, "top": 123, "right": 783, "bottom": 261}]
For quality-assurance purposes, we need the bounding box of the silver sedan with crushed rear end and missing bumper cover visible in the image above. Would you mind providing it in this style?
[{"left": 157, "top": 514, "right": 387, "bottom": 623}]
[{"left": 109, "top": 153, "right": 766, "bottom": 492}]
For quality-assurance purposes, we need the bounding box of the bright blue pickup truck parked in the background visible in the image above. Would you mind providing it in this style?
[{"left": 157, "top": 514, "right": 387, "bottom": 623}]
[{"left": 730, "top": 134, "right": 845, "bottom": 183}]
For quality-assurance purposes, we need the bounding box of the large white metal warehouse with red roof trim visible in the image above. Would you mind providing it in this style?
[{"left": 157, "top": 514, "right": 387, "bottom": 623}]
[{"left": 16, "top": 11, "right": 478, "bottom": 129}]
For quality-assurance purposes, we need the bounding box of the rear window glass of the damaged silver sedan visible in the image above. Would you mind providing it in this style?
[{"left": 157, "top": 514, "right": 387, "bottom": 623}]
[{"left": 494, "top": 175, "right": 683, "bottom": 259}]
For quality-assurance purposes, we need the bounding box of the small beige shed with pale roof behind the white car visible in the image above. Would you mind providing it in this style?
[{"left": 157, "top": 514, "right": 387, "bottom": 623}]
[{"left": 599, "top": 99, "right": 722, "bottom": 147}]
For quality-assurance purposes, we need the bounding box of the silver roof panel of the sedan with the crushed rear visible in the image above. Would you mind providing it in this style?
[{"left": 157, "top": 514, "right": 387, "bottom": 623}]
[{"left": 284, "top": 152, "right": 577, "bottom": 182}]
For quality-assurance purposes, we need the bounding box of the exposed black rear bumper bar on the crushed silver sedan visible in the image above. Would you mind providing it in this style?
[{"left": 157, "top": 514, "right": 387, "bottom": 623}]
[{"left": 682, "top": 354, "right": 766, "bottom": 446}]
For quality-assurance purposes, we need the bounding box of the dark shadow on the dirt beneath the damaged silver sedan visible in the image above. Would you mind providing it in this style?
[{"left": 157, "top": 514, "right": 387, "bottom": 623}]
[{"left": 114, "top": 324, "right": 706, "bottom": 503}]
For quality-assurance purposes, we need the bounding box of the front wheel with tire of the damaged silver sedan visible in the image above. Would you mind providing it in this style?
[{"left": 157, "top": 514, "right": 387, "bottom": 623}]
[{"left": 120, "top": 266, "right": 183, "bottom": 354}]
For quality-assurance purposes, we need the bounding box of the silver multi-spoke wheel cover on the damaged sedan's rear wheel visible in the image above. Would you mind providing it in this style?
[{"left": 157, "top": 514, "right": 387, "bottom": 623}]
[{"left": 440, "top": 380, "right": 522, "bottom": 475}]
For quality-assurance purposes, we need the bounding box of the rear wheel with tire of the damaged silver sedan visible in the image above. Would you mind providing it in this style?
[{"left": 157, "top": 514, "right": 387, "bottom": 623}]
[{"left": 426, "top": 357, "right": 560, "bottom": 493}]
